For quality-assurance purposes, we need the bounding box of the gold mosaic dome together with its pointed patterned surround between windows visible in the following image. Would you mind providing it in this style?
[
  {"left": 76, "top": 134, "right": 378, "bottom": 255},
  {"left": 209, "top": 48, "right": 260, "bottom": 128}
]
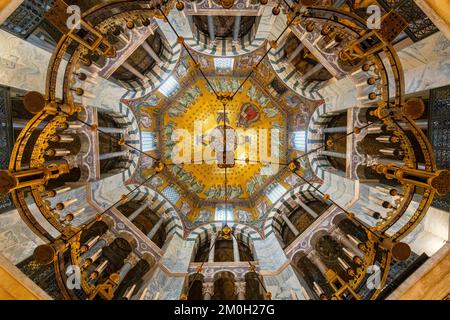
[{"left": 122, "top": 51, "right": 321, "bottom": 229}]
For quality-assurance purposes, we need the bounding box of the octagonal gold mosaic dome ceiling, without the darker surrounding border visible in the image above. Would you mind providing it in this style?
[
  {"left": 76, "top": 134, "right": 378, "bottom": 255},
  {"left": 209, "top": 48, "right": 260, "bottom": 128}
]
[{"left": 160, "top": 77, "right": 286, "bottom": 202}]
